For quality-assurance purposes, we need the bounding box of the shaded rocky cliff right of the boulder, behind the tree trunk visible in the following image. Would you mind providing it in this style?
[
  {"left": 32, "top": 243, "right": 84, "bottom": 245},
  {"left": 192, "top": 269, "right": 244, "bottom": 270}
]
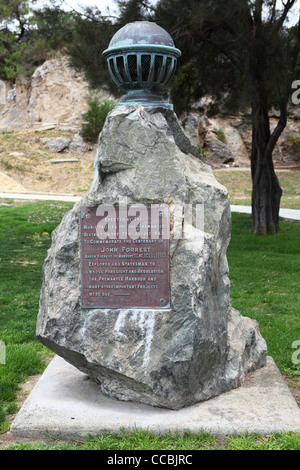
[{"left": 181, "top": 100, "right": 300, "bottom": 168}]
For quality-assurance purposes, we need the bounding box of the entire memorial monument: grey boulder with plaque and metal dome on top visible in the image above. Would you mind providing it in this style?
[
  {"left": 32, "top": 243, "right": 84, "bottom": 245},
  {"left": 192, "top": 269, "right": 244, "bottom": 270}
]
[{"left": 37, "top": 22, "right": 267, "bottom": 410}]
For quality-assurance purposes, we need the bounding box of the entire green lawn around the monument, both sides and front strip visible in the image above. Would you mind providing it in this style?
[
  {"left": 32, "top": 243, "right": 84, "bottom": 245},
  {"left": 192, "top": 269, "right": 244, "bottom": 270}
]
[{"left": 0, "top": 200, "right": 300, "bottom": 450}]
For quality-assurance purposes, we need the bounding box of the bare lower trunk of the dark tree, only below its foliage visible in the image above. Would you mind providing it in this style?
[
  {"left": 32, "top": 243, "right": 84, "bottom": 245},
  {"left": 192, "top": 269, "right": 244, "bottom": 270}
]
[{"left": 251, "top": 99, "right": 286, "bottom": 235}]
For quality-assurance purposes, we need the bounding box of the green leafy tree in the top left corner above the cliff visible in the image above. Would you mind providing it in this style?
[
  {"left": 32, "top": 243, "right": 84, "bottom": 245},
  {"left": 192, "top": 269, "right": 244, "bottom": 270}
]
[{"left": 0, "top": 0, "right": 74, "bottom": 82}]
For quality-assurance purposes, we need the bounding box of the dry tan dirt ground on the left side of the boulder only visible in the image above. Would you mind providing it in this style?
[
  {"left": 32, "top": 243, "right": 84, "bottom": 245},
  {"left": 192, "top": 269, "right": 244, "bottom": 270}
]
[{"left": 0, "top": 129, "right": 97, "bottom": 196}]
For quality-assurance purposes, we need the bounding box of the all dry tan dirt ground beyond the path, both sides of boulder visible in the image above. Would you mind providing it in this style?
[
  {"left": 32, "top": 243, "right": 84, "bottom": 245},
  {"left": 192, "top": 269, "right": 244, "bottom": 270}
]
[{"left": 0, "top": 128, "right": 300, "bottom": 201}]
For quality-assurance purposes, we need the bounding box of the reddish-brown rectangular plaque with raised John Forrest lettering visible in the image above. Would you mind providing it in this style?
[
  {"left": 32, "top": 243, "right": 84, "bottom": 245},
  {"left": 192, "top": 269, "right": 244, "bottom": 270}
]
[{"left": 80, "top": 205, "right": 170, "bottom": 308}]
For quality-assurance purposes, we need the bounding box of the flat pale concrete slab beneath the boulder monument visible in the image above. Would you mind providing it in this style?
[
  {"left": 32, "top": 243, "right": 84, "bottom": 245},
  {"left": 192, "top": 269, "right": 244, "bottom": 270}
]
[{"left": 11, "top": 356, "right": 300, "bottom": 439}]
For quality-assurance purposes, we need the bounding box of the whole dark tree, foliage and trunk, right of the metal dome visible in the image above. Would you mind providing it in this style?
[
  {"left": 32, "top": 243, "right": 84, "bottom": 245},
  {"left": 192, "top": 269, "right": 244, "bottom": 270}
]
[{"left": 155, "top": 0, "right": 300, "bottom": 234}]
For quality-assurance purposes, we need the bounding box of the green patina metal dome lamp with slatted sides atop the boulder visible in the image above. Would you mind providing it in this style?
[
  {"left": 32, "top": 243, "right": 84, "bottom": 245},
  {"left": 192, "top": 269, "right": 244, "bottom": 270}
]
[{"left": 103, "top": 21, "right": 181, "bottom": 108}]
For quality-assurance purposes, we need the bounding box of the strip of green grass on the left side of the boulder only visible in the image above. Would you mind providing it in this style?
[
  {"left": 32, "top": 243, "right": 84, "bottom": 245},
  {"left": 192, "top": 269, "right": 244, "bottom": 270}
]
[{"left": 0, "top": 201, "right": 71, "bottom": 431}]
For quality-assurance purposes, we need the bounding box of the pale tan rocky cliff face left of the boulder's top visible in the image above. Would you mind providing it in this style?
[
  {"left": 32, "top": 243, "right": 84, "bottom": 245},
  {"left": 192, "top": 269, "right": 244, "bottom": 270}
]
[{"left": 0, "top": 57, "right": 109, "bottom": 129}]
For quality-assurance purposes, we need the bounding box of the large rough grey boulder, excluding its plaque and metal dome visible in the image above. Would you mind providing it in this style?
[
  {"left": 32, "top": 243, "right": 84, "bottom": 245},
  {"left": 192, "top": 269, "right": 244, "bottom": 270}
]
[{"left": 37, "top": 105, "right": 267, "bottom": 409}]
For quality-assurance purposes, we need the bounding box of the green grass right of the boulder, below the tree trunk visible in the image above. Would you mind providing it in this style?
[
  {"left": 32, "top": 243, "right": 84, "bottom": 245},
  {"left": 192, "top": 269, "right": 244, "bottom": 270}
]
[{"left": 227, "top": 214, "right": 300, "bottom": 374}]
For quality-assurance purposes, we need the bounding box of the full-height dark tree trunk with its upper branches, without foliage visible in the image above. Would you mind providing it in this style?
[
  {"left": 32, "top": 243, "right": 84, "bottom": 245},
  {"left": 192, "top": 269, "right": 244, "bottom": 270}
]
[{"left": 248, "top": 4, "right": 294, "bottom": 235}]
